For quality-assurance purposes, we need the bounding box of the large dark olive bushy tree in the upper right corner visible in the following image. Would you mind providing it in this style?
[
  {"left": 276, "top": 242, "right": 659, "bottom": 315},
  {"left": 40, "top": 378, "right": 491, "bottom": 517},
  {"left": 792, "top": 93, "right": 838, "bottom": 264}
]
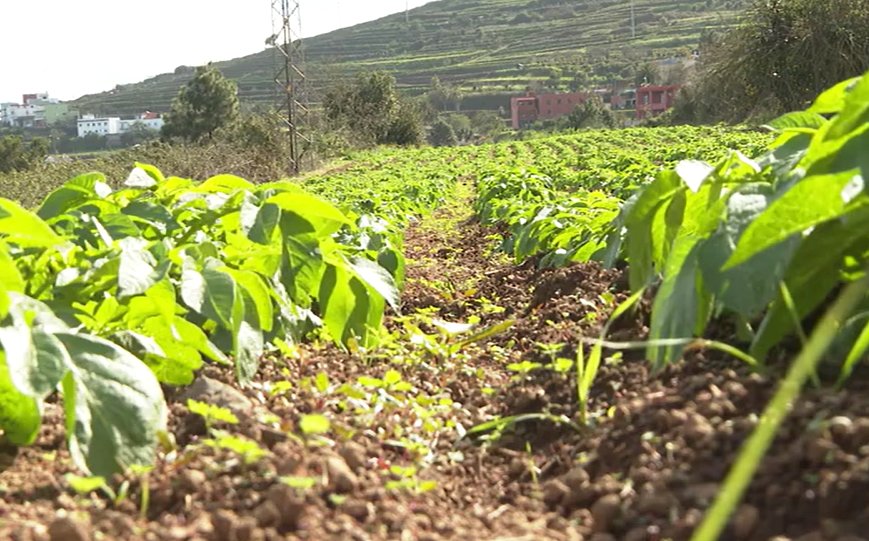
[{"left": 693, "top": 0, "right": 869, "bottom": 122}]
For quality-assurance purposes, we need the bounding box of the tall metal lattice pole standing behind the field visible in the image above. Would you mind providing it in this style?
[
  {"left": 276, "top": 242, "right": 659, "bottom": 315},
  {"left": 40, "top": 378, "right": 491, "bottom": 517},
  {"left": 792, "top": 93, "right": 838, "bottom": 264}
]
[{"left": 268, "top": 0, "right": 311, "bottom": 174}]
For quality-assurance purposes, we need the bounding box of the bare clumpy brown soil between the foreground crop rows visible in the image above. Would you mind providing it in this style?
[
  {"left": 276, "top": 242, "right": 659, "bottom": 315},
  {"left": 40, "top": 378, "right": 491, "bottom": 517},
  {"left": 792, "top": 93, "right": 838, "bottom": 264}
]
[{"left": 0, "top": 198, "right": 869, "bottom": 541}]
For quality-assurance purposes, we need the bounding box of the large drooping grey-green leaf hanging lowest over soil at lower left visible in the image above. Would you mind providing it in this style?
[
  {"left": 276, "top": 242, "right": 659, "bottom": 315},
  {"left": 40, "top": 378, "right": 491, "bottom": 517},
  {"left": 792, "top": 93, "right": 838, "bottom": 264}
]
[{"left": 55, "top": 332, "right": 166, "bottom": 477}]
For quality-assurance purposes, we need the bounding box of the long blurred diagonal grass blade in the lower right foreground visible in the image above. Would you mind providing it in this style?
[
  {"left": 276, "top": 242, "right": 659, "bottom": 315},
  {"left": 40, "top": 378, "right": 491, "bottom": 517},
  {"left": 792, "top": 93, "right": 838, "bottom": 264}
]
[{"left": 691, "top": 275, "right": 869, "bottom": 541}]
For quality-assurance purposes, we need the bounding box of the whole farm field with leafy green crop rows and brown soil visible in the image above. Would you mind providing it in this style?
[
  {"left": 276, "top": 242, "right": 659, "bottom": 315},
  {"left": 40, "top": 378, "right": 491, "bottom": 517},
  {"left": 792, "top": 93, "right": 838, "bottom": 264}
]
[{"left": 0, "top": 76, "right": 869, "bottom": 541}]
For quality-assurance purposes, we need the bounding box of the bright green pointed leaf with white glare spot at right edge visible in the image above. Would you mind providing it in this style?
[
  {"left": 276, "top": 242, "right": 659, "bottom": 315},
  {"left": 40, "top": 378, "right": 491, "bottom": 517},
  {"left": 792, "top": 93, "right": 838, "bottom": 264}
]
[{"left": 724, "top": 171, "right": 863, "bottom": 270}]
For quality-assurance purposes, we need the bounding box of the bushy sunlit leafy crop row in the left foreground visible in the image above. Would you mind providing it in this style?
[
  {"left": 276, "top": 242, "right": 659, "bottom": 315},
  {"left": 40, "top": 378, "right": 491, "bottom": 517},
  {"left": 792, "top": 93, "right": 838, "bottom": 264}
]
[{"left": 0, "top": 164, "right": 448, "bottom": 475}]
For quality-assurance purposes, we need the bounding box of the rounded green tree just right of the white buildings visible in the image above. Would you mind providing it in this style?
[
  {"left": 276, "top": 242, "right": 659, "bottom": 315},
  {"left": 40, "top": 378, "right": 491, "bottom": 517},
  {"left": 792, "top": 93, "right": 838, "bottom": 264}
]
[{"left": 163, "top": 64, "right": 239, "bottom": 141}]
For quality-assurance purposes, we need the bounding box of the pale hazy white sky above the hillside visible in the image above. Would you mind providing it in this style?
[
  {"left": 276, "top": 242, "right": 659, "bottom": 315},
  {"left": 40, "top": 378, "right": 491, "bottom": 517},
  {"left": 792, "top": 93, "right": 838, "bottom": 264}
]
[{"left": 0, "top": 0, "right": 430, "bottom": 102}]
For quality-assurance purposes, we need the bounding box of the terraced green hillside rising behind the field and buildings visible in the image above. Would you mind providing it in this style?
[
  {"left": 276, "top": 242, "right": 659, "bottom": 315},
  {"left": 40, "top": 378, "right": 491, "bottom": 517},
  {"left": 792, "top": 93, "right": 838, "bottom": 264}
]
[{"left": 75, "top": 0, "right": 746, "bottom": 114}]
